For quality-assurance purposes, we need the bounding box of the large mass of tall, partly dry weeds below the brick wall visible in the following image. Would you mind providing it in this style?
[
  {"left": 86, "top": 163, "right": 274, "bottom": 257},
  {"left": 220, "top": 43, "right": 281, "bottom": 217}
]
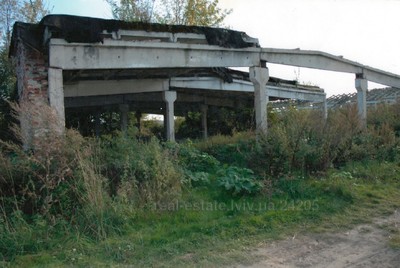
[{"left": 0, "top": 103, "right": 182, "bottom": 260}]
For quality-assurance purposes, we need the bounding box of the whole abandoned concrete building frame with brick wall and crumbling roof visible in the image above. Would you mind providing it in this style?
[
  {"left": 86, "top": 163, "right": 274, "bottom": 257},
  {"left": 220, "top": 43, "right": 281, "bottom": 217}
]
[{"left": 10, "top": 15, "right": 400, "bottom": 144}]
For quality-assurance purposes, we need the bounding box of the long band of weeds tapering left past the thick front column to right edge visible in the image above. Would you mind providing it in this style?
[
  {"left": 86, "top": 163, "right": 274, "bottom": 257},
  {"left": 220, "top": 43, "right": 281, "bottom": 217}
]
[{"left": 197, "top": 104, "right": 400, "bottom": 178}]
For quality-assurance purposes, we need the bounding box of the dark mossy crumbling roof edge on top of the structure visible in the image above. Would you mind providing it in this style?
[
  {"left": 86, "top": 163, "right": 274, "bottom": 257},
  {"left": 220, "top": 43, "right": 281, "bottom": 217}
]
[{"left": 10, "top": 15, "right": 259, "bottom": 55}]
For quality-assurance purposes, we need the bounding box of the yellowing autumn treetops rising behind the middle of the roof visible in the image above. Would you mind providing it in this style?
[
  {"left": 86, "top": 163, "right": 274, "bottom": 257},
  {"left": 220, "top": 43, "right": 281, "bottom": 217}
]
[{"left": 106, "top": 0, "right": 231, "bottom": 26}]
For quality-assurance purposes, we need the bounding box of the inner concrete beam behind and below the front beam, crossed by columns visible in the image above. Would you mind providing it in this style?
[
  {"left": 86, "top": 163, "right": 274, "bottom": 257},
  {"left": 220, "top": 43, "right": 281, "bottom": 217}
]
[{"left": 64, "top": 77, "right": 325, "bottom": 106}]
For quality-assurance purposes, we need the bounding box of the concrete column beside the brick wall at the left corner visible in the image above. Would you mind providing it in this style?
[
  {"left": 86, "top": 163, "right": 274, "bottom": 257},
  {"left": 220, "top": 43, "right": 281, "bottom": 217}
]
[{"left": 48, "top": 68, "right": 65, "bottom": 132}]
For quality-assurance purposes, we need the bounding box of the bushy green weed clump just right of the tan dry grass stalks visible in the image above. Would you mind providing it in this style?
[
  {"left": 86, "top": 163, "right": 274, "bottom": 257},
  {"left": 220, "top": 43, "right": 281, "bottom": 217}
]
[{"left": 101, "top": 129, "right": 183, "bottom": 207}]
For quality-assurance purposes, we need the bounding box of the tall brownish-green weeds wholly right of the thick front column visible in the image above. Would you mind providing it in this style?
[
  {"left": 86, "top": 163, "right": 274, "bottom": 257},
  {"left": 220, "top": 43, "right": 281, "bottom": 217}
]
[{"left": 257, "top": 102, "right": 400, "bottom": 175}]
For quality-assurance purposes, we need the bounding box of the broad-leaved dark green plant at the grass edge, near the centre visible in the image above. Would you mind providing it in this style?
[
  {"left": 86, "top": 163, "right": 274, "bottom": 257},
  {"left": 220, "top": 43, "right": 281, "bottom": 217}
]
[{"left": 217, "top": 166, "right": 262, "bottom": 196}]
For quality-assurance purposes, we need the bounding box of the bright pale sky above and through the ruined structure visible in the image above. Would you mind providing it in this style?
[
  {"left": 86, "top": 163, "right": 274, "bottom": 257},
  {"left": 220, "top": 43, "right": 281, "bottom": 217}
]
[{"left": 48, "top": 0, "right": 400, "bottom": 96}]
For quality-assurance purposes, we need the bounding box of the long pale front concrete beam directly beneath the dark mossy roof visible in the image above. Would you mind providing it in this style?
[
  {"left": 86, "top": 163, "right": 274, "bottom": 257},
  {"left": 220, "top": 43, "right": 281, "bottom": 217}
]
[{"left": 49, "top": 39, "right": 260, "bottom": 70}]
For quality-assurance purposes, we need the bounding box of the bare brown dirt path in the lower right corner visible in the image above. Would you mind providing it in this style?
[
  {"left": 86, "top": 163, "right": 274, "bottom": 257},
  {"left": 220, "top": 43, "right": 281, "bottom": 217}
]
[{"left": 237, "top": 211, "right": 400, "bottom": 267}]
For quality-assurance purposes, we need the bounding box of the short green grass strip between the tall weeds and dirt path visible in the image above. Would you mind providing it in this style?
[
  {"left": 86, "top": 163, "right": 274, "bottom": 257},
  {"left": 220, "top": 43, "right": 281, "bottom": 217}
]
[{"left": 2, "top": 164, "right": 400, "bottom": 267}]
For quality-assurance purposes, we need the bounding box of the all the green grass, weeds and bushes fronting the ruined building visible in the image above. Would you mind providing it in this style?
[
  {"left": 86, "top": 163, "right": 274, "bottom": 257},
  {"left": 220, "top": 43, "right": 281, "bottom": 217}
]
[{"left": 0, "top": 100, "right": 400, "bottom": 266}]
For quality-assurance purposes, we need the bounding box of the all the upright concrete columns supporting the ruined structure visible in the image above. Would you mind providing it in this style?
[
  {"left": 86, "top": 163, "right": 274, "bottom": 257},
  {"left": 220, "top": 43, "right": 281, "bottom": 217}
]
[{"left": 48, "top": 65, "right": 368, "bottom": 141}]
